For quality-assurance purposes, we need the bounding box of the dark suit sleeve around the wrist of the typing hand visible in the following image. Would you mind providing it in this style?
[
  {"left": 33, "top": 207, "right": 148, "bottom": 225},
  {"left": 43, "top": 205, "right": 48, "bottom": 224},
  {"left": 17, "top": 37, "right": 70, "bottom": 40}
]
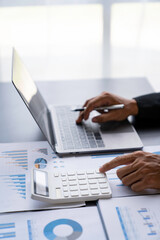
[{"left": 134, "top": 93, "right": 160, "bottom": 122}]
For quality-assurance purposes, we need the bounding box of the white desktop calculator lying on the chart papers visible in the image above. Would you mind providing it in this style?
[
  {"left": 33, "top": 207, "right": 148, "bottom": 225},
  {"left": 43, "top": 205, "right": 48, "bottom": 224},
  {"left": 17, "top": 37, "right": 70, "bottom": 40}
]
[{"left": 31, "top": 169, "right": 112, "bottom": 204}]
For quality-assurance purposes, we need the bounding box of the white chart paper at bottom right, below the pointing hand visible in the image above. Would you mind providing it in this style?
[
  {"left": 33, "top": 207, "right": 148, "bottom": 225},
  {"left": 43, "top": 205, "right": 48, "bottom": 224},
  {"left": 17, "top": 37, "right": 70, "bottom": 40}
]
[{"left": 98, "top": 195, "right": 160, "bottom": 240}]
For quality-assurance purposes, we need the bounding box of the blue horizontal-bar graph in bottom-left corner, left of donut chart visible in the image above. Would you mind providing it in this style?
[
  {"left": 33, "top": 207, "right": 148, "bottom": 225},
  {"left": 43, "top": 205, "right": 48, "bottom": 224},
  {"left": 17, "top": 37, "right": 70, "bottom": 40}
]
[{"left": 0, "top": 222, "right": 16, "bottom": 239}]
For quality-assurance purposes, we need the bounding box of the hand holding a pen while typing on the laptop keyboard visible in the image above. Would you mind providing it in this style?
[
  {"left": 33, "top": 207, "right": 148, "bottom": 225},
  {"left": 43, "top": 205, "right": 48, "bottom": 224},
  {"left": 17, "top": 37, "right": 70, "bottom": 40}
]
[{"left": 76, "top": 92, "right": 138, "bottom": 124}]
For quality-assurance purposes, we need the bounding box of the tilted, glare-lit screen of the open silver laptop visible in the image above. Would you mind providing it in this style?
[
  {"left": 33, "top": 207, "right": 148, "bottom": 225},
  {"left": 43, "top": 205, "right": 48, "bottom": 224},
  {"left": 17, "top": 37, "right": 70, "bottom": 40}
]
[{"left": 12, "top": 49, "right": 52, "bottom": 146}]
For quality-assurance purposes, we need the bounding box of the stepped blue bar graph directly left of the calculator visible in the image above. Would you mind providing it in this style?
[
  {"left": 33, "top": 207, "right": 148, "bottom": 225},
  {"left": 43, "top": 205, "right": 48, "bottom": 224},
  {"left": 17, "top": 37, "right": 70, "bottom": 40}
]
[{"left": 0, "top": 174, "right": 26, "bottom": 199}]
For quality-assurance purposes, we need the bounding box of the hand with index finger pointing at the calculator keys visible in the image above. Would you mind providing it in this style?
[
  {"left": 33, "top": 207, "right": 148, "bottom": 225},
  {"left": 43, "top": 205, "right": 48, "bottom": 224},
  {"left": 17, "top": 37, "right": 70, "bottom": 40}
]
[{"left": 99, "top": 151, "right": 160, "bottom": 192}]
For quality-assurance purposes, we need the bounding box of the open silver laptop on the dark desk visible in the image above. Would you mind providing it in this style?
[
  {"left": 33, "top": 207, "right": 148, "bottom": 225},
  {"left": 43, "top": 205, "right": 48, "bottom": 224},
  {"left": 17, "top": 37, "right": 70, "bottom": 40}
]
[{"left": 12, "top": 49, "right": 143, "bottom": 154}]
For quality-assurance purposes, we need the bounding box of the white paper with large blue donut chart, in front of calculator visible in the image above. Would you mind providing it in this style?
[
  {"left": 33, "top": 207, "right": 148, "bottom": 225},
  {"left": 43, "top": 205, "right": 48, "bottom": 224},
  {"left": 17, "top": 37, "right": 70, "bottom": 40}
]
[{"left": 0, "top": 206, "right": 106, "bottom": 240}]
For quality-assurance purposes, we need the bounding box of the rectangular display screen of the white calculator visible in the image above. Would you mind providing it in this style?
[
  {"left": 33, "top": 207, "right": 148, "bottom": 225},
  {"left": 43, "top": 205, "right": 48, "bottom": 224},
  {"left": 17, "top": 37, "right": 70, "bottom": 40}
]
[{"left": 34, "top": 170, "right": 49, "bottom": 197}]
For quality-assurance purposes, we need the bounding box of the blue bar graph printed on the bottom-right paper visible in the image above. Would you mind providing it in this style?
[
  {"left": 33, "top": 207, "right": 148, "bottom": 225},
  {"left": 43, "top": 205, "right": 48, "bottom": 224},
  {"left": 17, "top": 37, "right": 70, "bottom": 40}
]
[{"left": 116, "top": 207, "right": 160, "bottom": 240}]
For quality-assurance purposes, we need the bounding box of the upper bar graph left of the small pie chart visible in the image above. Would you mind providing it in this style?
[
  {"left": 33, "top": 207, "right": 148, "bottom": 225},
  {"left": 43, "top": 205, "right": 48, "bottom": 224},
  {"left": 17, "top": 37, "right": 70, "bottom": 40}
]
[{"left": 0, "top": 150, "right": 28, "bottom": 170}]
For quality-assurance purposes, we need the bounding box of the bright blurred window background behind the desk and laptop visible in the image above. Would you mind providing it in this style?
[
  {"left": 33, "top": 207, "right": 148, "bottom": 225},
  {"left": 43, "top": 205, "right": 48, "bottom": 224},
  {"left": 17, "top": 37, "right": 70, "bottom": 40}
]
[{"left": 0, "top": 0, "right": 160, "bottom": 91}]
